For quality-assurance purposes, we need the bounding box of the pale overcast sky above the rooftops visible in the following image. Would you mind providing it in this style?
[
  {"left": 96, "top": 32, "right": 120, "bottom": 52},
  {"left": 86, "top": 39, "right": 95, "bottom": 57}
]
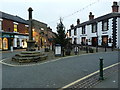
[{"left": 0, "top": 0, "right": 120, "bottom": 32}]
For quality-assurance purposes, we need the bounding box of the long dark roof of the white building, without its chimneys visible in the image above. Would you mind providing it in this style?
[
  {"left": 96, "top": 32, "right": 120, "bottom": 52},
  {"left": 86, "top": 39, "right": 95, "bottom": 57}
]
[{"left": 69, "top": 12, "right": 120, "bottom": 30}]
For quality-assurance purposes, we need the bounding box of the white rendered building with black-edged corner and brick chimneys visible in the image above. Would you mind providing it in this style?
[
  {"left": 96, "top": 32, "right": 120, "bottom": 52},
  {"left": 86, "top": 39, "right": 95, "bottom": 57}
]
[{"left": 68, "top": 2, "right": 120, "bottom": 48}]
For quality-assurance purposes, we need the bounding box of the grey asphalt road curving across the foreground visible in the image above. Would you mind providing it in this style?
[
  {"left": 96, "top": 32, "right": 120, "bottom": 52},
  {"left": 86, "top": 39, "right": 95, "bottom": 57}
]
[{"left": 2, "top": 52, "right": 120, "bottom": 88}]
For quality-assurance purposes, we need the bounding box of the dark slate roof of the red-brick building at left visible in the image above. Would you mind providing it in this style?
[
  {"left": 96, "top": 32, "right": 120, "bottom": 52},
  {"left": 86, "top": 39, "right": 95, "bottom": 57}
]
[{"left": 0, "top": 11, "right": 29, "bottom": 24}]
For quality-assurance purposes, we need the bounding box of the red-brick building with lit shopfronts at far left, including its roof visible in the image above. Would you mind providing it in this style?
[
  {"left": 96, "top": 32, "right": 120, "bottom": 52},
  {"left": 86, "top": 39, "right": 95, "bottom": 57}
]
[{"left": 0, "top": 11, "right": 28, "bottom": 50}]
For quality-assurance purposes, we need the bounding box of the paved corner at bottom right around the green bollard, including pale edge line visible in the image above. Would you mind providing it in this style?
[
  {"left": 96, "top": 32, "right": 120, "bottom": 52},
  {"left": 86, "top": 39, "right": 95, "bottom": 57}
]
[{"left": 60, "top": 63, "right": 120, "bottom": 90}]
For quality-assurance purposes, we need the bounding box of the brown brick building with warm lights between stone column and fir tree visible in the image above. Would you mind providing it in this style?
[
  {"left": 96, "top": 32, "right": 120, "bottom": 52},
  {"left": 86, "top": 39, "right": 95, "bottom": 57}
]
[{"left": 32, "top": 19, "right": 54, "bottom": 48}]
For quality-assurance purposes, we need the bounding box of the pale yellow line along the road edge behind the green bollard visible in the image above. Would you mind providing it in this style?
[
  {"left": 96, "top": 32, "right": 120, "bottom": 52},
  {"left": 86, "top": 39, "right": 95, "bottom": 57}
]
[{"left": 59, "top": 62, "right": 120, "bottom": 90}]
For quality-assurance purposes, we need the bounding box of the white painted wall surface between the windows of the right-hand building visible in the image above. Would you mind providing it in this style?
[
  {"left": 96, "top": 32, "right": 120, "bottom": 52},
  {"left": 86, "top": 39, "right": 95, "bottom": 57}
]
[{"left": 70, "top": 18, "right": 120, "bottom": 47}]
